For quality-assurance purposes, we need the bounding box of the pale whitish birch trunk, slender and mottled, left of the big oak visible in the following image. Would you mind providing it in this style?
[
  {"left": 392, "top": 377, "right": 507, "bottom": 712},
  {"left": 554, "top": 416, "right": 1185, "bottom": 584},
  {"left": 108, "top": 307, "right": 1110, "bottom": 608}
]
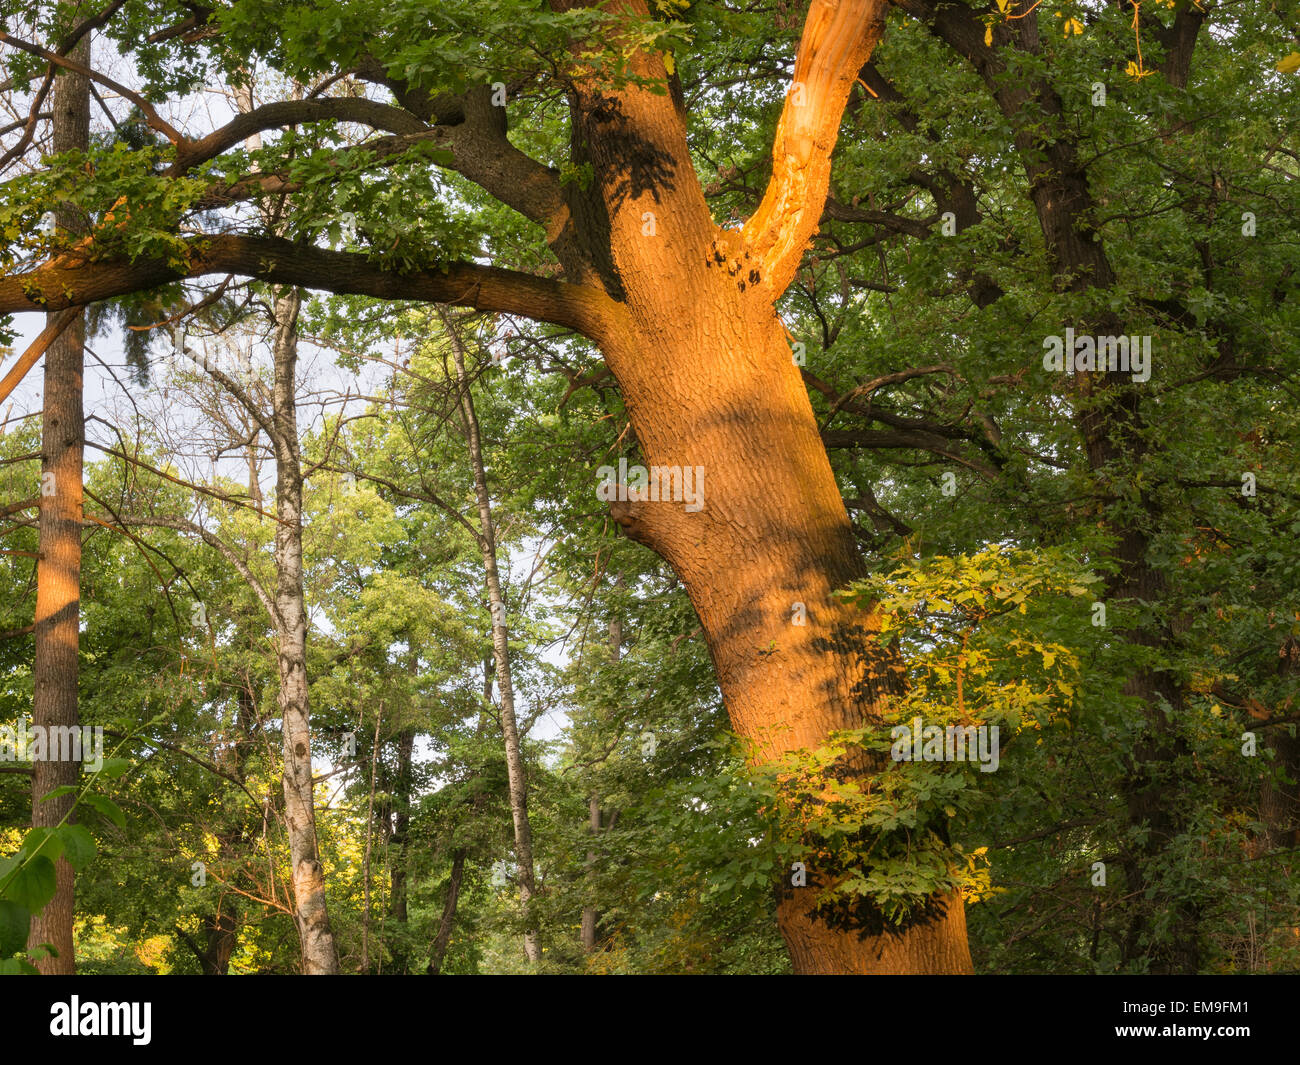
[{"left": 273, "top": 291, "right": 338, "bottom": 975}]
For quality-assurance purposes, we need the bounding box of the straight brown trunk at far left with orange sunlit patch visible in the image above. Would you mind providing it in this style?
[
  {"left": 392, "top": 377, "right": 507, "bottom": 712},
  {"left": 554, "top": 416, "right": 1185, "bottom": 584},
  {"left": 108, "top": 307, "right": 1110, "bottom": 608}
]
[{"left": 29, "top": 31, "right": 90, "bottom": 975}]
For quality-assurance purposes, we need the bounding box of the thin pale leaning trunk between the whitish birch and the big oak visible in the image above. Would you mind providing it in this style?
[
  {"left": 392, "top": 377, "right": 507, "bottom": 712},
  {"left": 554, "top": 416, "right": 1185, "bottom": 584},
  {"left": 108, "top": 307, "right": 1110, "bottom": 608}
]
[{"left": 442, "top": 313, "right": 542, "bottom": 964}]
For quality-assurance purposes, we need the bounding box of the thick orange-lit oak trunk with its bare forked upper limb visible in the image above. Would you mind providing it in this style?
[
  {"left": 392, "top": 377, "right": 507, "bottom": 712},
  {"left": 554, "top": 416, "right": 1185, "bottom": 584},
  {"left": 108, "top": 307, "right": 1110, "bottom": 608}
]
[{"left": 535, "top": 0, "right": 971, "bottom": 973}]
